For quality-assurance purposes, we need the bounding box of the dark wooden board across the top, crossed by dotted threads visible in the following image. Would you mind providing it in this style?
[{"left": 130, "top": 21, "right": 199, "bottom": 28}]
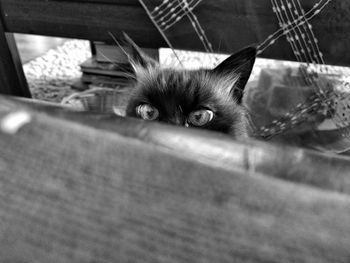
[{"left": 0, "top": 0, "right": 350, "bottom": 65}]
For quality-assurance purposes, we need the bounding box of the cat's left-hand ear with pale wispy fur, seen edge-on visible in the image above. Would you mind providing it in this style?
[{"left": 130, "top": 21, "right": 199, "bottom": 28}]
[{"left": 123, "top": 33, "right": 158, "bottom": 70}]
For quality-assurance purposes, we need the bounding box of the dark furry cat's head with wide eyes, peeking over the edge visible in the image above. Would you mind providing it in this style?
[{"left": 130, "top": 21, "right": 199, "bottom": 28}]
[{"left": 126, "top": 36, "right": 256, "bottom": 137}]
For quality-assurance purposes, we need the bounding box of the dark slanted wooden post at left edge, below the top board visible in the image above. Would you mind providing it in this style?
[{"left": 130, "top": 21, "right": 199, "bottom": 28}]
[{"left": 0, "top": 15, "right": 31, "bottom": 98}]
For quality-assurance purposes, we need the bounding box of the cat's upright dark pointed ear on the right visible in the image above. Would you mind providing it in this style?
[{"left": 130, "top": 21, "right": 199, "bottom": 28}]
[{"left": 212, "top": 46, "right": 257, "bottom": 103}]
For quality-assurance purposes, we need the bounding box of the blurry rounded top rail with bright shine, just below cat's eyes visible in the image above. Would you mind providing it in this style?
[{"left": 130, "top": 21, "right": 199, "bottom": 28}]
[{"left": 14, "top": 100, "right": 350, "bottom": 197}]
